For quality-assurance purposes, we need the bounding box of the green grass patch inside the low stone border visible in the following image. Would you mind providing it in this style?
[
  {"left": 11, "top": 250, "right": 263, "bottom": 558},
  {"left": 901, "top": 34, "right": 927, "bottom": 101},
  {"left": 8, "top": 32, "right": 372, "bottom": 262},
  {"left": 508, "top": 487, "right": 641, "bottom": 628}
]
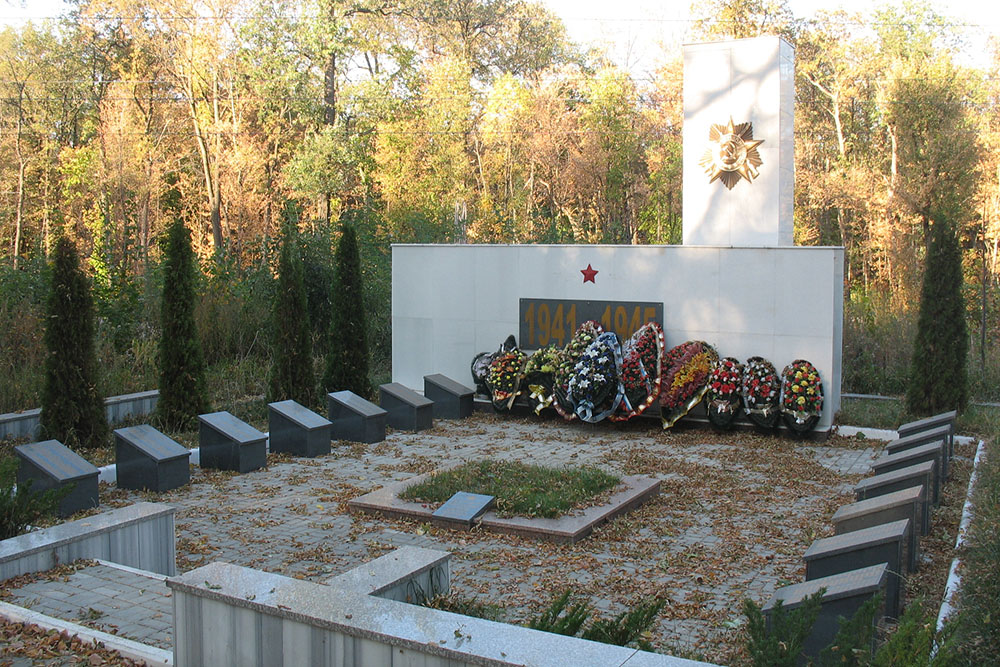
[{"left": 401, "top": 459, "right": 621, "bottom": 518}]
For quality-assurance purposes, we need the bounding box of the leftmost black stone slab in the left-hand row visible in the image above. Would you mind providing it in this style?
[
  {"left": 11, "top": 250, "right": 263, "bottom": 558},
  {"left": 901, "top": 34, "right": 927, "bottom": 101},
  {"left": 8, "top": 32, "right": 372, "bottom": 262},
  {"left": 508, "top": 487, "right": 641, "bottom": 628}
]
[{"left": 14, "top": 440, "right": 100, "bottom": 516}]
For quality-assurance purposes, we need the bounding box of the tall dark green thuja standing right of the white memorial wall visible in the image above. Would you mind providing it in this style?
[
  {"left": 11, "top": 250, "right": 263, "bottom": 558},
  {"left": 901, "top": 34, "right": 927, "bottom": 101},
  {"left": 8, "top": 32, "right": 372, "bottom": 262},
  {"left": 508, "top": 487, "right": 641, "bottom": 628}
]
[{"left": 906, "top": 217, "right": 969, "bottom": 415}]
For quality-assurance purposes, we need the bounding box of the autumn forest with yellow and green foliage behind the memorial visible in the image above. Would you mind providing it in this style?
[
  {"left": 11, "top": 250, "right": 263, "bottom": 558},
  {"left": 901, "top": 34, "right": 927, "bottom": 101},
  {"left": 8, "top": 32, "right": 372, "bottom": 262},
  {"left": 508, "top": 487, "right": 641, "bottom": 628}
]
[{"left": 0, "top": 0, "right": 1000, "bottom": 412}]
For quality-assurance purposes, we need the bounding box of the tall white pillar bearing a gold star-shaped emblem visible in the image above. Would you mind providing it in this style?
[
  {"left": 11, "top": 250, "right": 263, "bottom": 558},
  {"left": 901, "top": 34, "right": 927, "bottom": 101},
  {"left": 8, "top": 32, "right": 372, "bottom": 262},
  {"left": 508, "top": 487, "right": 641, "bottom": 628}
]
[{"left": 684, "top": 37, "right": 795, "bottom": 247}]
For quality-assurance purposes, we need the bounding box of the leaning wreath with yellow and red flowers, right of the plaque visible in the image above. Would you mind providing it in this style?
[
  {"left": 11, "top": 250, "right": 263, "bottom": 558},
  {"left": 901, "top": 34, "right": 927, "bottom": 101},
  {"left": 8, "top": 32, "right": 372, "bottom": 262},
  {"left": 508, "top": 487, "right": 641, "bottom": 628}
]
[{"left": 660, "top": 340, "right": 719, "bottom": 428}]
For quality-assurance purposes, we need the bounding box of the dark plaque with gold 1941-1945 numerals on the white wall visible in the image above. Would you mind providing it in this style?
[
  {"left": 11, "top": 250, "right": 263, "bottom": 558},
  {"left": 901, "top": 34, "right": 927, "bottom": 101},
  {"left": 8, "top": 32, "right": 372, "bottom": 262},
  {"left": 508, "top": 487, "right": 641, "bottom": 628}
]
[{"left": 518, "top": 299, "right": 663, "bottom": 350}]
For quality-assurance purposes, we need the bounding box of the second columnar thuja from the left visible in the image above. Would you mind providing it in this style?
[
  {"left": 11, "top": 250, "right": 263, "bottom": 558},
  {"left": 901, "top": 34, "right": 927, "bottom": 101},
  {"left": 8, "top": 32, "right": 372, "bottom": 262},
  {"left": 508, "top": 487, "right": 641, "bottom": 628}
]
[{"left": 156, "top": 216, "right": 208, "bottom": 429}]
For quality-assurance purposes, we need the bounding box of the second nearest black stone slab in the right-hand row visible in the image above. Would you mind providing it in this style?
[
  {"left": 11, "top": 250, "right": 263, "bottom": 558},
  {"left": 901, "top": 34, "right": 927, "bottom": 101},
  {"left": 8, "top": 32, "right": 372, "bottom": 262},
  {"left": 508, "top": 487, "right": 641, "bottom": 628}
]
[{"left": 802, "top": 519, "right": 913, "bottom": 618}]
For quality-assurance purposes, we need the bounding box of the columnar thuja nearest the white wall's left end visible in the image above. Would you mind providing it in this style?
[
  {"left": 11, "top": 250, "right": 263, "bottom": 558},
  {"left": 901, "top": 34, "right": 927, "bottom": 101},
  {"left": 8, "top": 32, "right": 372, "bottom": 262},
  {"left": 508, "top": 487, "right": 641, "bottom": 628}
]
[{"left": 323, "top": 223, "right": 371, "bottom": 396}]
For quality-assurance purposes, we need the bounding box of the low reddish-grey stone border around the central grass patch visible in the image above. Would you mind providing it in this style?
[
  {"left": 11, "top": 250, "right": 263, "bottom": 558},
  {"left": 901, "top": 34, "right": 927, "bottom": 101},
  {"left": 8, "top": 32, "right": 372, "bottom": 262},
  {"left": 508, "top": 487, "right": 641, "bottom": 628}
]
[{"left": 347, "top": 470, "right": 660, "bottom": 544}]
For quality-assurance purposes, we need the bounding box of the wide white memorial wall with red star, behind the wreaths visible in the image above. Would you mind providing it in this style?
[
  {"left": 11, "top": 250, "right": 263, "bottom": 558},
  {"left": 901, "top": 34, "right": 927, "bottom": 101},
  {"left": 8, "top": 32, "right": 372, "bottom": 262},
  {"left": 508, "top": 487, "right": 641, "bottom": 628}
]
[{"left": 392, "top": 245, "right": 844, "bottom": 430}]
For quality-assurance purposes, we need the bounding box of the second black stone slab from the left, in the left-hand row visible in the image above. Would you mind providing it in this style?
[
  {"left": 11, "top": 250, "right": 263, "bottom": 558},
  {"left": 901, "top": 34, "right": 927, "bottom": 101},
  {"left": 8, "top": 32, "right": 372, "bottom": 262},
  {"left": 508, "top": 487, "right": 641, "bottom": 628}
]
[{"left": 115, "top": 424, "right": 191, "bottom": 492}]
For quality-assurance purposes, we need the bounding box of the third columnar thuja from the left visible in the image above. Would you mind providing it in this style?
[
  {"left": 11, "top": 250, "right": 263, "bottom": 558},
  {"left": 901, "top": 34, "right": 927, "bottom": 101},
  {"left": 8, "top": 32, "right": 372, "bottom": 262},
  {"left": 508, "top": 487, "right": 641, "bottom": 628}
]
[{"left": 267, "top": 204, "right": 316, "bottom": 405}]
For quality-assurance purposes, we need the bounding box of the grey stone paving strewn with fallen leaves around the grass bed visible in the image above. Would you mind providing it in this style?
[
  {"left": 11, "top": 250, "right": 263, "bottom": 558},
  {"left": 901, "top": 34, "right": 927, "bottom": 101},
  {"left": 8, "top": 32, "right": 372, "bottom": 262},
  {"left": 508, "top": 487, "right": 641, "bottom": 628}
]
[{"left": 5, "top": 413, "right": 879, "bottom": 664}]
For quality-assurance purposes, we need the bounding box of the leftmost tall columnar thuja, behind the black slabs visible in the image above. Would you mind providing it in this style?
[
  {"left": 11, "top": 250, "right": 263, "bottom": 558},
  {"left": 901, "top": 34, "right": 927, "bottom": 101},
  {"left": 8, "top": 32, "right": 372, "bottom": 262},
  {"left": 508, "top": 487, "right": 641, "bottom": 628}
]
[{"left": 41, "top": 237, "right": 108, "bottom": 447}]
